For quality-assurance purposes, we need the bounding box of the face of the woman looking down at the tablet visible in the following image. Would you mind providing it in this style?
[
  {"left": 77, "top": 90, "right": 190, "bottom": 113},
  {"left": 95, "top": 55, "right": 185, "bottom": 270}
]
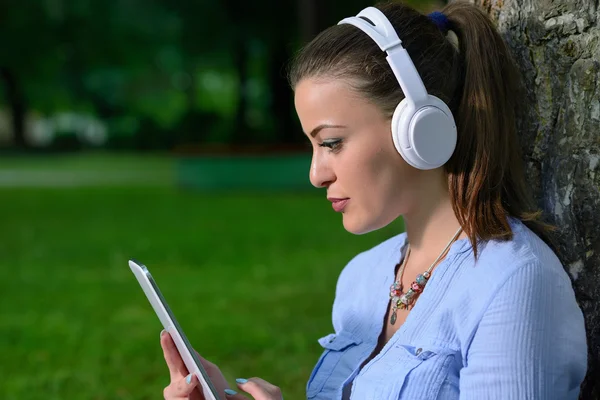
[{"left": 295, "top": 79, "right": 424, "bottom": 234}]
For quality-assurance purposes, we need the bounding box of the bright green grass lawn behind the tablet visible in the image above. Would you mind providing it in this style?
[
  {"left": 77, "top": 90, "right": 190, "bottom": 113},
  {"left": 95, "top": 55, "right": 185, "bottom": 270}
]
[{"left": 0, "top": 161, "right": 401, "bottom": 400}]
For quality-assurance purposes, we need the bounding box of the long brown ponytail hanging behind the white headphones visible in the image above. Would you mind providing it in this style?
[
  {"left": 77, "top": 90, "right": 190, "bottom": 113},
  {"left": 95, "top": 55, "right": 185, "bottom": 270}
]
[{"left": 443, "top": 2, "right": 552, "bottom": 255}]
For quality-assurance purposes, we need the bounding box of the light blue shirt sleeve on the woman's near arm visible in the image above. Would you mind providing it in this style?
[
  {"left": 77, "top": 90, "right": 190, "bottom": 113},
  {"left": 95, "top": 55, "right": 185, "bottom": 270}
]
[{"left": 460, "top": 263, "right": 587, "bottom": 400}]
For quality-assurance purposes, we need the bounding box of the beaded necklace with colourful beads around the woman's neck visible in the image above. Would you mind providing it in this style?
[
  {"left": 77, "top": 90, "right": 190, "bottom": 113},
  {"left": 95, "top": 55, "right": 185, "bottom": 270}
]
[{"left": 390, "top": 227, "right": 462, "bottom": 325}]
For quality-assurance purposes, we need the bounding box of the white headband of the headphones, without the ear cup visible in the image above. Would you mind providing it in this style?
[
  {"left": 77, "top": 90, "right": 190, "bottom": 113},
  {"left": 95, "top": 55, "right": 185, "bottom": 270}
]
[{"left": 338, "top": 7, "right": 428, "bottom": 107}]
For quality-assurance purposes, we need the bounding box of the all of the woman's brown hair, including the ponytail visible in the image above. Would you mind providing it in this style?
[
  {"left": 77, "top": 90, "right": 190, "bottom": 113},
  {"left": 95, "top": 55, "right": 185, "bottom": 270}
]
[{"left": 289, "top": 2, "right": 554, "bottom": 256}]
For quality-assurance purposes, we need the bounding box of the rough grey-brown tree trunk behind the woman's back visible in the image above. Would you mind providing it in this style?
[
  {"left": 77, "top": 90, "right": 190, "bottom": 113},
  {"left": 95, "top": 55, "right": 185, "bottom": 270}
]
[{"left": 471, "top": 0, "right": 600, "bottom": 400}]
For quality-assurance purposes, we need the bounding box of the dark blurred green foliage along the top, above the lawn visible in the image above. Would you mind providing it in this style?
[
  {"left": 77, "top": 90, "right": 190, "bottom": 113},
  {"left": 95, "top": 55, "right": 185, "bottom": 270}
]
[{"left": 0, "top": 0, "right": 440, "bottom": 148}]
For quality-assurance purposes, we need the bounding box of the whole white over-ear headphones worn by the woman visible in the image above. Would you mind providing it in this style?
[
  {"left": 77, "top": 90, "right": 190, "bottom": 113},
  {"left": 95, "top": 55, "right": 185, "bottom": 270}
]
[{"left": 338, "top": 7, "right": 456, "bottom": 170}]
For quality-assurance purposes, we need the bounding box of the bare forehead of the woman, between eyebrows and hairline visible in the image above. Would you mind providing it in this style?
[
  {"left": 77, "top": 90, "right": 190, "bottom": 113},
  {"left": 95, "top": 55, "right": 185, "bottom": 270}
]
[{"left": 294, "top": 79, "right": 374, "bottom": 132}]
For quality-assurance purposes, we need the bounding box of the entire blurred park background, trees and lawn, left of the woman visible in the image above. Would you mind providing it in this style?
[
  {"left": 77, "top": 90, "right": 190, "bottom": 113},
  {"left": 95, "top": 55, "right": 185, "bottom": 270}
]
[{"left": 0, "top": 0, "right": 443, "bottom": 400}]
